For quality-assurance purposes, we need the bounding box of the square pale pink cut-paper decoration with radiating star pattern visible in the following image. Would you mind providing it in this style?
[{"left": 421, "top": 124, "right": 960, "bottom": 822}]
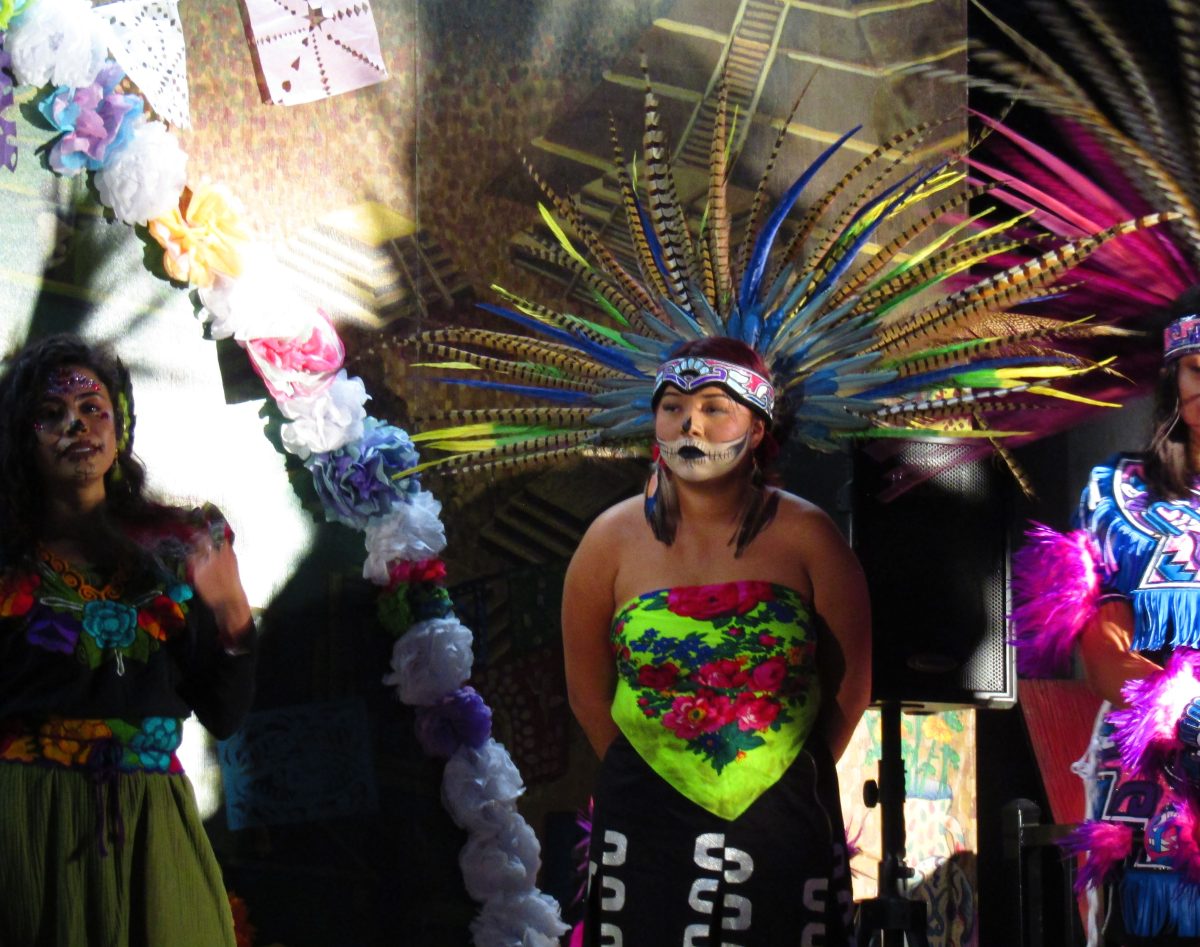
[{"left": 246, "top": 0, "right": 388, "bottom": 106}]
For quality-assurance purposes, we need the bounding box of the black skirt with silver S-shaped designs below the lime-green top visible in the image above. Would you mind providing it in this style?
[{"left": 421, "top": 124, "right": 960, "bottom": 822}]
[{"left": 584, "top": 736, "right": 853, "bottom": 947}]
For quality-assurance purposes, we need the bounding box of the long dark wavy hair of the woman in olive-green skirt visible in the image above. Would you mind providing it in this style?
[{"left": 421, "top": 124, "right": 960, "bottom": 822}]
[{"left": 0, "top": 335, "right": 159, "bottom": 562}]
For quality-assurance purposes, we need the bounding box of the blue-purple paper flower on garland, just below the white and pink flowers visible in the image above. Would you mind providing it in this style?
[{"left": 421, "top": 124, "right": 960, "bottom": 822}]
[{"left": 305, "top": 418, "right": 420, "bottom": 529}]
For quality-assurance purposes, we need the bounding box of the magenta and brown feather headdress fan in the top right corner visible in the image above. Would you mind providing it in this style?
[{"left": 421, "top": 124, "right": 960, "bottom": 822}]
[{"left": 910, "top": 0, "right": 1200, "bottom": 324}]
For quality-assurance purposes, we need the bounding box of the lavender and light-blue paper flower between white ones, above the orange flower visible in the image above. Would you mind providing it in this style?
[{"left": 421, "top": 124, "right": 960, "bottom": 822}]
[{"left": 37, "top": 60, "right": 143, "bottom": 176}]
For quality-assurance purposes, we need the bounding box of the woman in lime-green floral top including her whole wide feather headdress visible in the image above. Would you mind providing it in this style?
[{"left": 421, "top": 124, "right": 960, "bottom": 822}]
[{"left": 413, "top": 53, "right": 1163, "bottom": 947}]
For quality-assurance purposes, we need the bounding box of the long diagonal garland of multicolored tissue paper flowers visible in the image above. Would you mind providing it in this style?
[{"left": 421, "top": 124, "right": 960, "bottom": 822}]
[{"left": 0, "top": 0, "right": 566, "bottom": 947}]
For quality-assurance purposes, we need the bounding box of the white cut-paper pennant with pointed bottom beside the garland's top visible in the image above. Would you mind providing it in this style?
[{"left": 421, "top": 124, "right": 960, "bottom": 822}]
[{"left": 92, "top": 0, "right": 191, "bottom": 128}]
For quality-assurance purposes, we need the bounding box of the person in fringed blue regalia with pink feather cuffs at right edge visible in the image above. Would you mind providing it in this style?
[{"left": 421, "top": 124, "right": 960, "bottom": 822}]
[{"left": 1013, "top": 288, "right": 1200, "bottom": 947}]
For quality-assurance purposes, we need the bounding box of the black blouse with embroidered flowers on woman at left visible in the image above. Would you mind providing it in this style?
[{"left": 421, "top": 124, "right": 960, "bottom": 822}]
[{"left": 0, "top": 516, "right": 254, "bottom": 749}]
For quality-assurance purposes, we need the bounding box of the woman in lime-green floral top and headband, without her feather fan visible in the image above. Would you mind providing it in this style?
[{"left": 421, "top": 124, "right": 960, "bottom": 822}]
[{"left": 563, "top": 338, "right": 871, "bottom": 945}]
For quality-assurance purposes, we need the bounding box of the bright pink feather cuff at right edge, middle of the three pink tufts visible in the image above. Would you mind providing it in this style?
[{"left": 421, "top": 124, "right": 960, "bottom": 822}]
[{"left": 1109, "top": 648, "right": 1200, "bottom": 774}]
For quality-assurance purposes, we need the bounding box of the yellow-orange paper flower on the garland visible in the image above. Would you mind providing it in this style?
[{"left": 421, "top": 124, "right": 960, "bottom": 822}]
[{"left": 149, "top": 185, "right": 250, "bottom": 287}]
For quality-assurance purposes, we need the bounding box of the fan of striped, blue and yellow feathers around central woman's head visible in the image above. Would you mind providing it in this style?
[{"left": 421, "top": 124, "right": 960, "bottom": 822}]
[{"left": 413, "top": 64, "right": 1164, "bottom": 473}]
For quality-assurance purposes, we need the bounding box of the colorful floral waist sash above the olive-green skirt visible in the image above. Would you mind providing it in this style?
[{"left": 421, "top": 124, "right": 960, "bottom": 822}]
[{"left": 0, "top": 717, "right": 184, "bottom": 780}]
